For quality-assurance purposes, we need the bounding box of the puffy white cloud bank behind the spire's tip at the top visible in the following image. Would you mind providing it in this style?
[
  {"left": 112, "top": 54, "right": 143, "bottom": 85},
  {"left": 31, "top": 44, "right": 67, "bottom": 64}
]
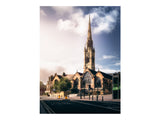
[{"left": 54, "top": 7, "right": 118, "bottom": 36}]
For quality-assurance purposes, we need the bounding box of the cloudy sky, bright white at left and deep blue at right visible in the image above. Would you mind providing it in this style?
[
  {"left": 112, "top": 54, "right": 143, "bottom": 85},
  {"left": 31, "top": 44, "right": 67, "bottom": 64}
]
[{"left": 40, "top": 6, "right": 120, "bottom": 83}]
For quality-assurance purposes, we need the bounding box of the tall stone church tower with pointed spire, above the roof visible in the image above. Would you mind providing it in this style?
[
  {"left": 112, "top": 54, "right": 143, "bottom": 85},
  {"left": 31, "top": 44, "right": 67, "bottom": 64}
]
[{"left": 84, "top": 16, "right": 95, "bottom": 70}]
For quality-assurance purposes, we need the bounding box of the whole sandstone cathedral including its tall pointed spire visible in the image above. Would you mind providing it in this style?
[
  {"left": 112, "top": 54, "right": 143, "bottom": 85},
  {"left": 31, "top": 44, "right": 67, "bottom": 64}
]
[{"left": 46, "top": 16, "right": 120, "bottom": 94}]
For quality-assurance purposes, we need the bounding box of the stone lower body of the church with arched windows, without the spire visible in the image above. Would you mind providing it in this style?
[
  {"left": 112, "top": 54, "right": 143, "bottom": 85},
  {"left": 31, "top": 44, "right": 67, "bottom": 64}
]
[{"left": 46, "top": 68, "right": 112, "bottom": 94}]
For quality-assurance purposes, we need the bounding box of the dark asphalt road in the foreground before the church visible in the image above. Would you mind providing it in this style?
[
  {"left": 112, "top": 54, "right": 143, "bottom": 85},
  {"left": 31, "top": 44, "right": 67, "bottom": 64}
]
[{"left": 40, "top": 99, "right": 120, "bottom": 114}]
